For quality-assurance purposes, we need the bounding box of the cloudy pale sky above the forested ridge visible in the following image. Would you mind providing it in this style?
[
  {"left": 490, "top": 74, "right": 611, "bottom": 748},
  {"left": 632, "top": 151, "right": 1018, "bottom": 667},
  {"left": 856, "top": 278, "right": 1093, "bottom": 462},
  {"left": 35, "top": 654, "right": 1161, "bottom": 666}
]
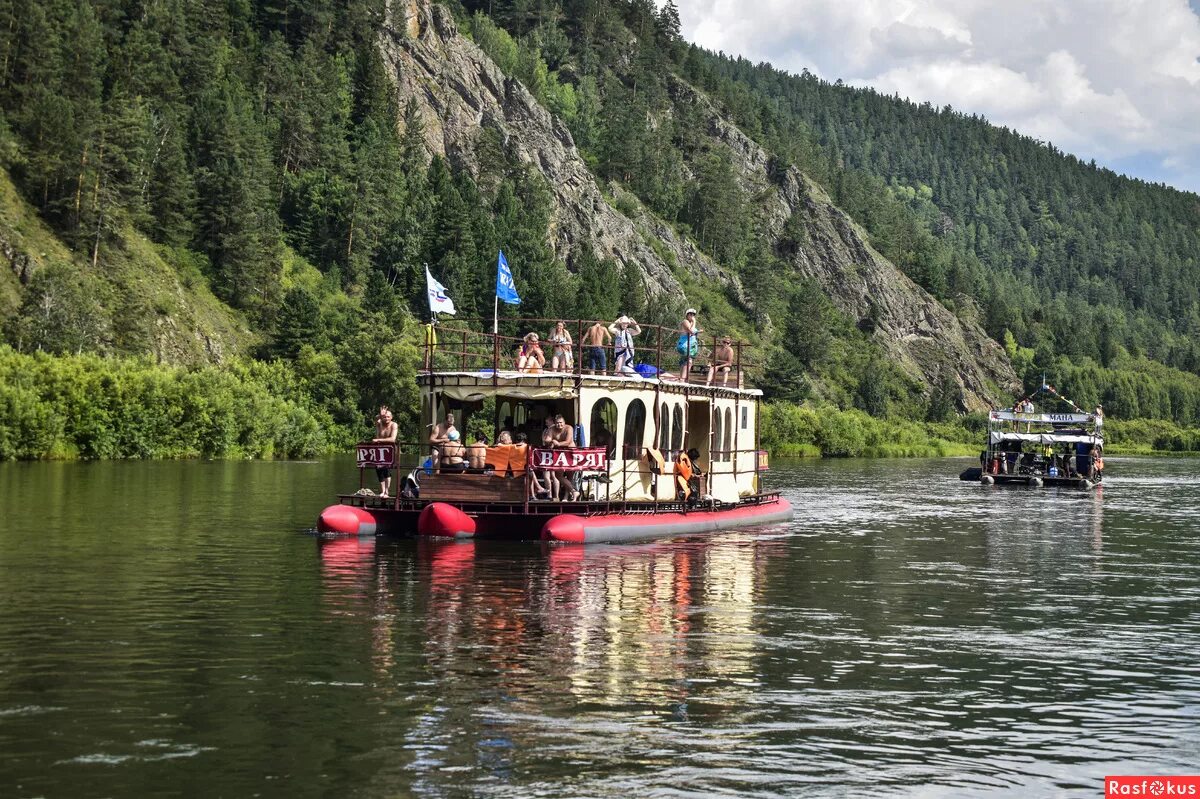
[{"left": 676, "top": 0, "right": 1200, "bottom": 191}]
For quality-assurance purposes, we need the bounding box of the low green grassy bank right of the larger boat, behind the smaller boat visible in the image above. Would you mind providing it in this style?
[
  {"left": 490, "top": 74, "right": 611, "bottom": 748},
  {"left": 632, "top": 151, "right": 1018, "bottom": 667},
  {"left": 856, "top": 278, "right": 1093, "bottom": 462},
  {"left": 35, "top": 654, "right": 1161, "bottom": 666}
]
[{"left": 762, "top": 402, "right": 1200, "bottom": 458}]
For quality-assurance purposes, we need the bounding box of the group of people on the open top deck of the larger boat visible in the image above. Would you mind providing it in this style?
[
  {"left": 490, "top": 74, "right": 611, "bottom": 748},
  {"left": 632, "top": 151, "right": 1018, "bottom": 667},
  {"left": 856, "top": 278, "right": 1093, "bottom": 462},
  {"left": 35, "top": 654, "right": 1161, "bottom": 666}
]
[{"left": 514, "top": 308, "right": 736, "bottom": 385}]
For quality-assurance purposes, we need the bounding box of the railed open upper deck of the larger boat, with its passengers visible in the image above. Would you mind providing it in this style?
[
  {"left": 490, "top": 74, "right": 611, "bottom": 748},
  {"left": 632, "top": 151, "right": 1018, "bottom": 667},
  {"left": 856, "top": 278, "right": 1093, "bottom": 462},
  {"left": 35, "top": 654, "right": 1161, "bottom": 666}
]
[{"left": 420, "top": 317, "right": 762, "bottom": 396}]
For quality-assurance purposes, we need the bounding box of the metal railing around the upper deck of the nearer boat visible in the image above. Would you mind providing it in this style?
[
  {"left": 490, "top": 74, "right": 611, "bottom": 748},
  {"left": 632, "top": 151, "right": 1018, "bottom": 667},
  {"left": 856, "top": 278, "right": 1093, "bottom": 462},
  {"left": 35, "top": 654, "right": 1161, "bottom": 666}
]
[{"left": 422, "top": 318, "right": 762, "bottom": 389}]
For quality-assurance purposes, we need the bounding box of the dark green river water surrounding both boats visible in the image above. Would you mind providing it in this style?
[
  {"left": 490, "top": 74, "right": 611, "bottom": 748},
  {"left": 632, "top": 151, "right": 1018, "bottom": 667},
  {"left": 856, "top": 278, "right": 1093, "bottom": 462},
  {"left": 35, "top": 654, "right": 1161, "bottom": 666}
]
[{"left": 0, "top": 458, "right": 1200, "bottom": 797}]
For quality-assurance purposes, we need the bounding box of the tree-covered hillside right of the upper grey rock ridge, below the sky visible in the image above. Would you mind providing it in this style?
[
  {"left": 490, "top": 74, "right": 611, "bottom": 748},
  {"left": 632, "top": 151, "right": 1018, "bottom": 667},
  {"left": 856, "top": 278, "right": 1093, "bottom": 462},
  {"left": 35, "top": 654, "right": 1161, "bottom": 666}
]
[{"left": 453, "top": 0, "right": 1200, "bottom": 423}]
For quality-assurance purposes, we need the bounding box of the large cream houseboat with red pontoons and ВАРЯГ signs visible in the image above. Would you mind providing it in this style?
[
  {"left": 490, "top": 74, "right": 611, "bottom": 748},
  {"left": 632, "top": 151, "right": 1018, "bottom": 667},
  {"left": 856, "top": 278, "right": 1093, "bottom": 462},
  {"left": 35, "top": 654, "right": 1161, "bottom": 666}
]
[{"left": 317, "top": 318, "right": 792, "bottom": 543}]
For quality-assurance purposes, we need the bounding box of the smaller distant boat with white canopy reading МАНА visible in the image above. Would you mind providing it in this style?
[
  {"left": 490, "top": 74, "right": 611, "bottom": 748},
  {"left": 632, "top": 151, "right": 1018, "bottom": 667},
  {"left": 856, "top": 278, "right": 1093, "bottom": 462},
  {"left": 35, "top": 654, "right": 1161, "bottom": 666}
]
[{"left": 959, "top": 386, "right": 1104, "bottom": 488}]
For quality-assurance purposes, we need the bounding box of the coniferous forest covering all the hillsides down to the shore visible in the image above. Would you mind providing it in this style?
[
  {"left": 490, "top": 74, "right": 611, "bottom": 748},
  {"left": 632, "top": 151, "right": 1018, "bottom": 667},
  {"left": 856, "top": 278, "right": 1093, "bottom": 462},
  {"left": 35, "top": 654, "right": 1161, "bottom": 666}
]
[{"left": 0, "top": 0, "right": 1200, "bottom": 458}]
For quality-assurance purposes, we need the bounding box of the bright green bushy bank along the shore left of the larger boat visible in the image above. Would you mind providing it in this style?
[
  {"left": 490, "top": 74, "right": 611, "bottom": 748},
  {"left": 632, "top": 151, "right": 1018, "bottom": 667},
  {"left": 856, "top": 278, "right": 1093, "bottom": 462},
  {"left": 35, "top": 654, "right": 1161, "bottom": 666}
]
[{"left": 0, "top": 347, "right": 349, "bottom": 459}]
